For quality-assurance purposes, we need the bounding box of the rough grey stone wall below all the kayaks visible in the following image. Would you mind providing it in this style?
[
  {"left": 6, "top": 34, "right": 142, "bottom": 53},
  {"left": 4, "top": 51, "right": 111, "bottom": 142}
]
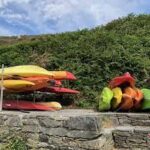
[{"left": 0, "top": 109, "right": 150, "bottom": 150}]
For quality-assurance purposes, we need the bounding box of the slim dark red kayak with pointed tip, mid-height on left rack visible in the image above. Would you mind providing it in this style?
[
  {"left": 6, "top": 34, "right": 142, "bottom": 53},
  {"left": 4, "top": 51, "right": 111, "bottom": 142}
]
[{"left": 40, "top": 87, "right": 80, "bottom": 94}]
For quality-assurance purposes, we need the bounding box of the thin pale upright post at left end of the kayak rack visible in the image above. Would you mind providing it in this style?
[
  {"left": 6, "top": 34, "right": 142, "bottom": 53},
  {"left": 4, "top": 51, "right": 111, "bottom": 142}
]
[{"left": 0, "top": 64, "right": 4, "bottom": 111}]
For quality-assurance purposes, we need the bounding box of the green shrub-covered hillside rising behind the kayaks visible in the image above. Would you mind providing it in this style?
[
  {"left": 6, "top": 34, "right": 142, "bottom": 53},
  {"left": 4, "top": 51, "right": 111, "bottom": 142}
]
[{"left": 0, "top": 15, "right": 150, "bottom": 107}]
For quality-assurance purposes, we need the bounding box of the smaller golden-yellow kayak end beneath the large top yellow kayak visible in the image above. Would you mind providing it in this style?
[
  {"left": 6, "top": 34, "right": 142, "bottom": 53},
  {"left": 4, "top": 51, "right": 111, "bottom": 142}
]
[{"left": 3, "top": 80, "right": 35, "bottom": 90}]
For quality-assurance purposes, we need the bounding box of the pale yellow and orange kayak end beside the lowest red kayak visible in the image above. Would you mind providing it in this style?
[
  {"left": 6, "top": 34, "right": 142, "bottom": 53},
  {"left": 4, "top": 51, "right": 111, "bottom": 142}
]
[{"left": 38, "top": 102, "right": 62, "bottom": 110}]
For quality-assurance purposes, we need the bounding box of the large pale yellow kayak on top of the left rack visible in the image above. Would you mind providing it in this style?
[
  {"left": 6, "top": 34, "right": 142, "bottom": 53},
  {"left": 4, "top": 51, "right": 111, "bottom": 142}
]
[{"left": 0, "top": 65, "right": 53, "bottom": 79}]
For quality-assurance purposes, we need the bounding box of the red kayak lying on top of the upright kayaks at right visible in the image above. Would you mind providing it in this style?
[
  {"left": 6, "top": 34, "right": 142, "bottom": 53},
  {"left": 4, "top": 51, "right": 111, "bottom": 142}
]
[{"left": 109, "top": 72, "right": 135, "bottom": 88}]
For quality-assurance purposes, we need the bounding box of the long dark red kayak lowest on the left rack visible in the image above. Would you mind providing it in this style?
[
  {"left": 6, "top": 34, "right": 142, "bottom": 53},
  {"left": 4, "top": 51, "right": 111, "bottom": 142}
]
[{"left": 3, "top": 100, "right": 55, "bottom": 111}]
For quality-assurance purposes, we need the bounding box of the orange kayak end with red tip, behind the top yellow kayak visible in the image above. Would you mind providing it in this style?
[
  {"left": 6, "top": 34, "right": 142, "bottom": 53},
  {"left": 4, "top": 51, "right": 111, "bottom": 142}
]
[{"left": 49, "top": 71, "right": 76, "bottom": 80}]
